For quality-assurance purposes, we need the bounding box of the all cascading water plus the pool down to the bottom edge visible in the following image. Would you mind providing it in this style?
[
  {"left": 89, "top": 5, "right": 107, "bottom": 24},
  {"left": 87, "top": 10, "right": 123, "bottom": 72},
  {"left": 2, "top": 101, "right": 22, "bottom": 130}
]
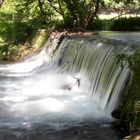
[{"left": 0, "top": 34, "right": 129, "bottom": 140}]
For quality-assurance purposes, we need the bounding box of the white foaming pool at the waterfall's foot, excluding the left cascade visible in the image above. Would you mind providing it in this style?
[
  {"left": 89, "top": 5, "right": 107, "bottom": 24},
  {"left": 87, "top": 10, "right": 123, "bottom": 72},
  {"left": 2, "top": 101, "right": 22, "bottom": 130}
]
[{"left": 0, "top": 72, "right": 106, "bottom": 128}]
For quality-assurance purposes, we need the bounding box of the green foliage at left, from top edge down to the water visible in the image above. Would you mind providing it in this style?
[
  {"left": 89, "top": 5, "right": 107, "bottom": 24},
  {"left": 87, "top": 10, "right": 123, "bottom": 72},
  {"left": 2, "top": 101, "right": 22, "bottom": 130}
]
[{"left": 0, "top": 0, "right": 52, "bottom": 60}]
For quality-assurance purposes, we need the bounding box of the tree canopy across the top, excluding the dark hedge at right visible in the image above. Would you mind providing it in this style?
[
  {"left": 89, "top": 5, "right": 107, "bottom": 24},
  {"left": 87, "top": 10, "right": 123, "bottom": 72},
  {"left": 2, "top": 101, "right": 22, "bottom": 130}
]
[{"left": 0, "top": 0, "right": 140, "bottom": 46}]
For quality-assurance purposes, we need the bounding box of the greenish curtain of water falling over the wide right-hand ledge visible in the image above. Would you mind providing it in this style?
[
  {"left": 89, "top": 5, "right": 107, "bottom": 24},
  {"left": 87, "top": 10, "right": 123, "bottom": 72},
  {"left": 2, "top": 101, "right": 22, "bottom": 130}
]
[{"left": 58, "top": 37, "right": 130, "bottom": 115}]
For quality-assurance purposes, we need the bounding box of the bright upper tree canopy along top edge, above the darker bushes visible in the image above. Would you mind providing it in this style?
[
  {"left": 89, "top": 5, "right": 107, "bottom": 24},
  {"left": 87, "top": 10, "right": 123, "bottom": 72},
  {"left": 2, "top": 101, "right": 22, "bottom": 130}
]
[{"left": 0, "top": 0, "right": 140, "bottom": 28}]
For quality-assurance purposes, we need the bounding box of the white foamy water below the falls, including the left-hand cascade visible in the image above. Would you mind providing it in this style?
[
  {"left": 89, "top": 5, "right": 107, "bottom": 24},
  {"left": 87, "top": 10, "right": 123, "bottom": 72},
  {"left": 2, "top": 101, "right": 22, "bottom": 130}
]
[{"left": 0, "top": 47, "right": 108, "bottom": 127}]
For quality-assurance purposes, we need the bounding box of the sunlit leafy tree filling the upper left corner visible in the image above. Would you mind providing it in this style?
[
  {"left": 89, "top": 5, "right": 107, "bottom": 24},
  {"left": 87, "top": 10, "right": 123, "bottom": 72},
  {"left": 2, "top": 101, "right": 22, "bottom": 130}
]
[{"left": 0, "top": 0, "right": 53, "bottom": 43}]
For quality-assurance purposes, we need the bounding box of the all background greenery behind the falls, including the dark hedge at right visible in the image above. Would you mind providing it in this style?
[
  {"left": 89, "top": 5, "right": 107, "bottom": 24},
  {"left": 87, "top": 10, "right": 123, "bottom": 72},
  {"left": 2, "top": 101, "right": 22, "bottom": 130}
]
[{"left": 0, "top": 0, "right": 140, "bottom": 60}]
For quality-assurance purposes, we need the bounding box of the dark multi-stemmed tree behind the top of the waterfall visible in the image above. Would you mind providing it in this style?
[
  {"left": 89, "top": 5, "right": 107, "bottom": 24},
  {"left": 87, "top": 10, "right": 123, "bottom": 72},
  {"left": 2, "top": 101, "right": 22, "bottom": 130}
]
[{"left": 48, "top": 0, "right": 101, "bottom": 28}]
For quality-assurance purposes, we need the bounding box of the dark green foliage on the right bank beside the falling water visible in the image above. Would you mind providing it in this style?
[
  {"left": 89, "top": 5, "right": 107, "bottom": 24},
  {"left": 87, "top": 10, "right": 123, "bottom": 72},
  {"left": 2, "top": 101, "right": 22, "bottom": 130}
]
[{"left": 115, "top": 48, "right": 140, "bottom": 133}]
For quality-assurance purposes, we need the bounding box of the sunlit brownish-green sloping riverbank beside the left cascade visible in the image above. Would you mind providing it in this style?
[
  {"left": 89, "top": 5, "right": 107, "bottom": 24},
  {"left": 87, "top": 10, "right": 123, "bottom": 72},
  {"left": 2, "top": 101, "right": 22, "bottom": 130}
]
[{"left": 1, "top": 29, "right": 51, "bottom": 63}]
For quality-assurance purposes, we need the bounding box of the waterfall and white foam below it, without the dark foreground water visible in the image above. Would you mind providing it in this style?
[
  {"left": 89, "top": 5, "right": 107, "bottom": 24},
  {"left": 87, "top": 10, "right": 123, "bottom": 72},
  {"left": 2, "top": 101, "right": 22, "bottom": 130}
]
[{"left": 0, "top": 35, "right": 128, "bottom": 127}]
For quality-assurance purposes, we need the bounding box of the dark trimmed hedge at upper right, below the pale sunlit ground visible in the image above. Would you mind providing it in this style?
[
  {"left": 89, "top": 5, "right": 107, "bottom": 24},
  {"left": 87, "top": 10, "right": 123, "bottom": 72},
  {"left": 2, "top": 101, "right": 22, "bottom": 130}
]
[{"left": 110, "top": 17, "right": 140, "bottom": 31}]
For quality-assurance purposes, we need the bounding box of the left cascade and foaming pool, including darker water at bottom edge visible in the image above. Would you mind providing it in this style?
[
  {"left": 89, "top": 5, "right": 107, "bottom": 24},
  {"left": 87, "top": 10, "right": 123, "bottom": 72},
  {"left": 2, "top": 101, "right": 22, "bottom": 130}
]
[{"left": 0, "top": 35, "right": 131, "bottom": 140}]
